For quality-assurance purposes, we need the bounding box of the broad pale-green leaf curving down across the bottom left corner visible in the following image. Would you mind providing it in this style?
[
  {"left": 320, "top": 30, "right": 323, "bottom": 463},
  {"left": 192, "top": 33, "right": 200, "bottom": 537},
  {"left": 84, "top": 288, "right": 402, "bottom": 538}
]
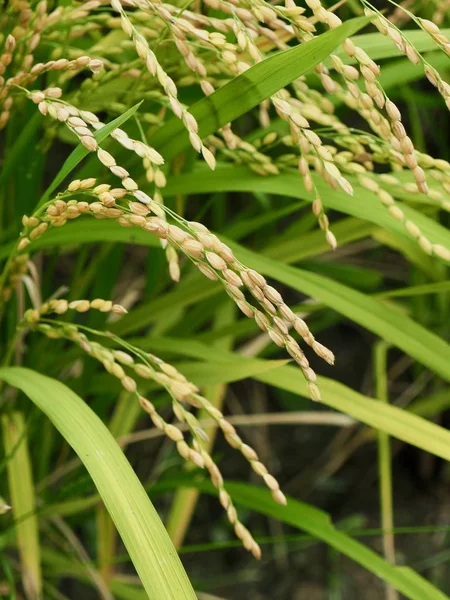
[{"left": 0, "top": 367, "right": 196, "bottom": 600}]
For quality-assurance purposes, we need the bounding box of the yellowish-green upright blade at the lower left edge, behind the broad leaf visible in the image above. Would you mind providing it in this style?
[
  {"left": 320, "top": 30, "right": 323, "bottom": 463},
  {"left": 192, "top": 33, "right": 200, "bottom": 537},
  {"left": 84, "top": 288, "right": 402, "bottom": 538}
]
[{"left": 1, "top": 412, "right": 42, "bottom": 598}]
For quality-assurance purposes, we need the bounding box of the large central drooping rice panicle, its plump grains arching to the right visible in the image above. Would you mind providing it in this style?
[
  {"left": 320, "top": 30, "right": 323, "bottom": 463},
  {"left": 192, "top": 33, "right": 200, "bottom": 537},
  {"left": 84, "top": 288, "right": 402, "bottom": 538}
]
[{"left": 18, "top": 171, "right": 334, "bottom": 400}]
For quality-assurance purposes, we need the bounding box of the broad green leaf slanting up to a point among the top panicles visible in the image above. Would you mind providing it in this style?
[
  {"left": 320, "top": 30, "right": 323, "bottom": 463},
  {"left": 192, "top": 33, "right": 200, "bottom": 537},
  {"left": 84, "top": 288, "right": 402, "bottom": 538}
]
[{"left": 151, "top": 17, "right": 370, "bottom": 160}]
